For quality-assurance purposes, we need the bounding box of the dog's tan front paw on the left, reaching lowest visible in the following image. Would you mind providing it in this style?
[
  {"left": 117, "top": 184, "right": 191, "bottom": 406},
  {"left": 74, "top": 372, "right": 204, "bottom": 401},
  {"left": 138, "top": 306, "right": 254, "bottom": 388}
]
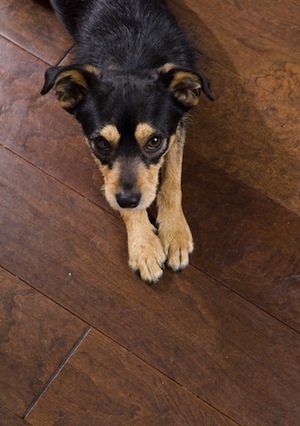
[{"left": 128, "top": 226, "right": 166, "bottom": 283}]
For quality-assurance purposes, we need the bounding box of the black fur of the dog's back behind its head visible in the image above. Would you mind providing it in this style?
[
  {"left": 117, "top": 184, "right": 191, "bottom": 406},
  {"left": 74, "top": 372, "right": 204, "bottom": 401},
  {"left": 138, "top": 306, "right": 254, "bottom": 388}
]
[{"left": 51, "top": 0, "right": 195, "bottom": 72}]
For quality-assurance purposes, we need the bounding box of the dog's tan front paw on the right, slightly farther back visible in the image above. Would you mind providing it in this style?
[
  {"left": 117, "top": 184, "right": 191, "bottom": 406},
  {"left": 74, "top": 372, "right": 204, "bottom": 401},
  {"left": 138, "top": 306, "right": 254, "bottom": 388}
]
[{"left": 158, "top": 213, "right": 194, "bottom": 271}]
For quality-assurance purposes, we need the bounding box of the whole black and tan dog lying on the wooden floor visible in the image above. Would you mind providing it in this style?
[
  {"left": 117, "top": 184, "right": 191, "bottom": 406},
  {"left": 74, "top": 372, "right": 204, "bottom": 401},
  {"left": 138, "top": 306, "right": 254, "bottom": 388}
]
[{"left": 41, "top": 0, "right": 213, "bottom": 282}]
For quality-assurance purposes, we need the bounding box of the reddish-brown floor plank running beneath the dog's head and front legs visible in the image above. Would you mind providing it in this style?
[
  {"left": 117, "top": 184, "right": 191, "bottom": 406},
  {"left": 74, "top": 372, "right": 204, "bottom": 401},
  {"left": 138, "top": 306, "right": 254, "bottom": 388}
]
[{"left": 0, "top": 34, "right": 300, "bottom": 330}]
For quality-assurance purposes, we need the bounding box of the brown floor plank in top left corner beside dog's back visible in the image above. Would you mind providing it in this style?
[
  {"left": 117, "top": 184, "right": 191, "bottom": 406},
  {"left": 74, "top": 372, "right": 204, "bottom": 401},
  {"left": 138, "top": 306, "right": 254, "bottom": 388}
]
[{"left": 0, "top": 0, "right": 73, "bottom": 68}]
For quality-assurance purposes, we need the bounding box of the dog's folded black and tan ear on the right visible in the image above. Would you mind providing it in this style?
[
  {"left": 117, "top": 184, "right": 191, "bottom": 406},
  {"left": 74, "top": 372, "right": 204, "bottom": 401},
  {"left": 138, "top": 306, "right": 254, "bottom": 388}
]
[{"left": 158, "top": 64, "right": 214, "bottom": 109}]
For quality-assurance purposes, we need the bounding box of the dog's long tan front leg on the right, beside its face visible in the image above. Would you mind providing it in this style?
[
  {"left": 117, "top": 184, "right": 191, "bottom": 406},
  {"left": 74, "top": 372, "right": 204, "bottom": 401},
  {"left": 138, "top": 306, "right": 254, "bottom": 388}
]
[{"left": 157, "top": 124, "right": 193, "bottom": 271}]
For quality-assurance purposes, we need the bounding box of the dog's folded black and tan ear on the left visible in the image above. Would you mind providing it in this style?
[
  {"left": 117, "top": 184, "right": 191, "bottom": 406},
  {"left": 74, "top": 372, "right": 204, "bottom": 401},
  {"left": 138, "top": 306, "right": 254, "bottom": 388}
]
[{"left": 41, "top": 65, "right": 100, "bottom": 113}]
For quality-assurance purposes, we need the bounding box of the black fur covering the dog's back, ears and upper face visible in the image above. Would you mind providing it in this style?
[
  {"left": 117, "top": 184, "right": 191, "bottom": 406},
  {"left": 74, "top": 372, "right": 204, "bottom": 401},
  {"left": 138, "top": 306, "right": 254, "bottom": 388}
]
[{"left": 41, "top": 0, "right": 213, "bottom": 203}]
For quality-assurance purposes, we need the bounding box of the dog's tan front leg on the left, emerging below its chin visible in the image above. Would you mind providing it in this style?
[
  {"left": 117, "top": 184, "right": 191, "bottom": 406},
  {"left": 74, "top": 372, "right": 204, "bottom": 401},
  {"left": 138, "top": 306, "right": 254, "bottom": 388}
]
[{"left": 120, "top": 210, "right": 166, "bottom": 283}]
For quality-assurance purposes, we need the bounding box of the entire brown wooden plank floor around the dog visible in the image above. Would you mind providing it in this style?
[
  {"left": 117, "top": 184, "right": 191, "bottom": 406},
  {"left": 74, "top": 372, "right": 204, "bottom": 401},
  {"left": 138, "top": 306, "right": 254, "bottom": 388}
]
[{"left": 0, "top": 0, "right": 300, "bottom": 426}]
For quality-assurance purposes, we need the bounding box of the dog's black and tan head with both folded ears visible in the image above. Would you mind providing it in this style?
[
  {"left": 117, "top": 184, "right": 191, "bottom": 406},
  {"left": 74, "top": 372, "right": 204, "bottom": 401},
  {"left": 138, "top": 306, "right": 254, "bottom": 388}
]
[{"left": 41, "top": 64, "right": 213, "bottom": 209}]
